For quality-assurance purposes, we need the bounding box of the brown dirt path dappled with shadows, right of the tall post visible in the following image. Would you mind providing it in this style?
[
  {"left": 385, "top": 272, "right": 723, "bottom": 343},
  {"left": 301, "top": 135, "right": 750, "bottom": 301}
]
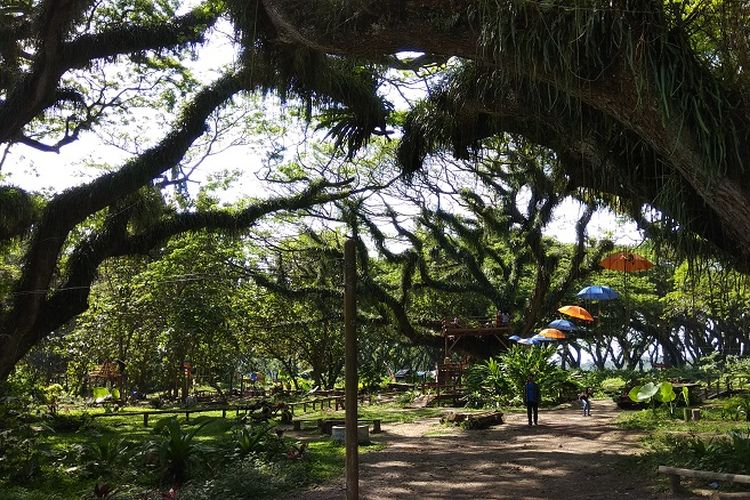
[{"left": 295, "top": 401, "right": 704, "bottom": 500}]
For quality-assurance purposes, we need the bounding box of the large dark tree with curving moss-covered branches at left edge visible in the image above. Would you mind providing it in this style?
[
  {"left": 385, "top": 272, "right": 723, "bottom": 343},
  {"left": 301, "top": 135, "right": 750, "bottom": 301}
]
[{"left": 0, "top": 0, "right": 385, "bottom": 380}]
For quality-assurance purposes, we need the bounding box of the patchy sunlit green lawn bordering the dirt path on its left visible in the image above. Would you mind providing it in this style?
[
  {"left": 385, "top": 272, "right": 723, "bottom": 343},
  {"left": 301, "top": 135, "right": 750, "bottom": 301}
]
[{"left": 0, "top": 404, "right": 412, "bottom": 500}]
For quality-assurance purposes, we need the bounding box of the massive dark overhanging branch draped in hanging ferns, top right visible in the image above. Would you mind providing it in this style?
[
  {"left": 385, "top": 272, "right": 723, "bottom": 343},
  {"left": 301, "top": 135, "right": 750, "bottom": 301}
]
[{"left": 253, "top": 0, "right": 750, "bottom": 270}]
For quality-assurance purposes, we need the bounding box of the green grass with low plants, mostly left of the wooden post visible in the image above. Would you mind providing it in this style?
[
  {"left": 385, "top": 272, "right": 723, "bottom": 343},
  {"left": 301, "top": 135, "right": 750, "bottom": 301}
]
[{"left": 0, "top": 404, "right": 414, "bottom": 500}]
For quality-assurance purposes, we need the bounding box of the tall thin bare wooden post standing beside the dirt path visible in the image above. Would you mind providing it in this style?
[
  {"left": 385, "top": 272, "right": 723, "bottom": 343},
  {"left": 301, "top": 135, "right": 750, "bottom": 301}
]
[{"left": 344, "top": 239, "right": 359, "bottom": 500}]
